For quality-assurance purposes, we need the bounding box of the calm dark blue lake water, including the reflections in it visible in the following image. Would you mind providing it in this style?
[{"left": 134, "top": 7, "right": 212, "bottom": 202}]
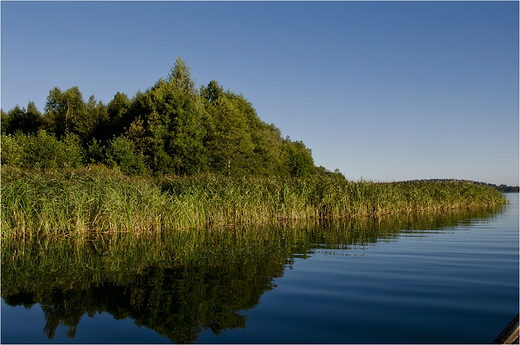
[{"left": 1, "top": 194, "right": 519, "bottom": 343}]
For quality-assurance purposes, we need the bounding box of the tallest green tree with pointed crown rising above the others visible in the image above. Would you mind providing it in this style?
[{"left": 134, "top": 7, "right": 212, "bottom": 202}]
[{"left": 125, "top": 58, "right": 208, "bottom": 175}]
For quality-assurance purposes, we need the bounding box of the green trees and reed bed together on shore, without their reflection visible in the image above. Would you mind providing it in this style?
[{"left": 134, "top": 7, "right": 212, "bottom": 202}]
[{"left": 1, "top": 58, "right": 505, "bottom": 238}]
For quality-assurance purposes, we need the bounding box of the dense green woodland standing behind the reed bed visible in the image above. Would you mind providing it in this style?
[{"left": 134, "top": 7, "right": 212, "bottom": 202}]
[{"left": 1, "top": 58, "right": 328, "bottom": 176}]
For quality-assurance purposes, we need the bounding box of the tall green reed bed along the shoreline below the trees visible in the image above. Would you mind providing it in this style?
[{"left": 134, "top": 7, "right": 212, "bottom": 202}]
[{"left": 1, "top": 166, "right": 506, "bottom": 238}]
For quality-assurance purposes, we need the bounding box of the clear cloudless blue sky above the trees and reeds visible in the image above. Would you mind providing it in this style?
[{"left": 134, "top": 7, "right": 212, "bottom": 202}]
[{"left": 1, "top": 1, "right": 519, "bottom": 185}]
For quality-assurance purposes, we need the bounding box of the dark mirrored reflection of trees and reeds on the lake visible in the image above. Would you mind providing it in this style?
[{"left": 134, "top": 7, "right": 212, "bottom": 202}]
[{"left": 2, "top": 207, "right": 503, "bottom": 343}]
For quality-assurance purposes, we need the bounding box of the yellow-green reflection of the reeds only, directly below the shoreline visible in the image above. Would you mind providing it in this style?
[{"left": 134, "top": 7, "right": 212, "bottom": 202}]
[{"left": 1, "top": 205, "right": 503, "bottom": 297}]
